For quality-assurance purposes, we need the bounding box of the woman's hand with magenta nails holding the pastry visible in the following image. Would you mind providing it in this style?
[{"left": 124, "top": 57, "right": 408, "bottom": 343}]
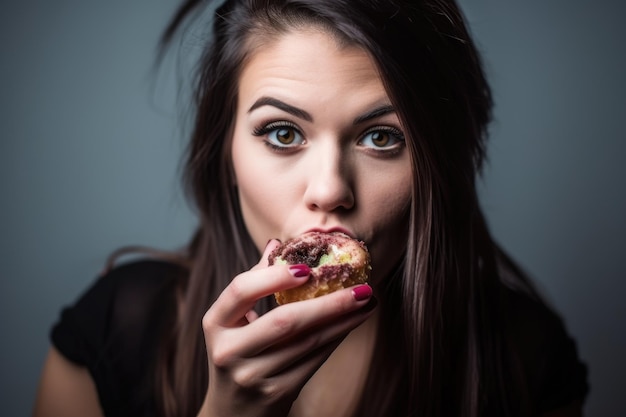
[{"left": 201, "top": 241, "right": 375, "bottom": 417}]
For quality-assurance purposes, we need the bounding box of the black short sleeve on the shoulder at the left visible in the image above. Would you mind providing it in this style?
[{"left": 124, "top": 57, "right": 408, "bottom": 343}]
[{"left": 51, "top": 261, "right": 184, "bottom": 416}]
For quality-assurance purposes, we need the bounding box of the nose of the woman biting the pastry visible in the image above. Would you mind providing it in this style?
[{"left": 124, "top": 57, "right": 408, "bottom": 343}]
[{"left": 304, "top": 146, "right": 355, "bottom": 212}]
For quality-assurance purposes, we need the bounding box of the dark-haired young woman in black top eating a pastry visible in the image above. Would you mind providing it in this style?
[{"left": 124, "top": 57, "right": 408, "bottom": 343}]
[{"left": 30, "top": 0, "right": 587, "bottom": 417}]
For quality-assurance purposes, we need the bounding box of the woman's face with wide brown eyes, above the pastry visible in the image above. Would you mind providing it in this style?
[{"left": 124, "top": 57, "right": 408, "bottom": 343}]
[{"left": 232, "top": 29, "right": 412, "bottom": 282}]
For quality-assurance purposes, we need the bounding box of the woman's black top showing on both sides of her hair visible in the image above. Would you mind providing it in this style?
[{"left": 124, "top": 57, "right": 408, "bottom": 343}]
[{"left": 51, "top": 260, "right": 588, "bottom": 417}]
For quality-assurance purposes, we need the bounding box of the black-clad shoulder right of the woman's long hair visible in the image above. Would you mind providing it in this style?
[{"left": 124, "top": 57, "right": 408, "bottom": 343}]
[{"left": 505, "top": 290, "right": 589, "bottom": 412}]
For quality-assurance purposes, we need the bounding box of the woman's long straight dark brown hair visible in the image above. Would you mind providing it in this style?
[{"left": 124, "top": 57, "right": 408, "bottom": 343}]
[{"left": 157, "top": 0, "right": 532, "bottom": 417}]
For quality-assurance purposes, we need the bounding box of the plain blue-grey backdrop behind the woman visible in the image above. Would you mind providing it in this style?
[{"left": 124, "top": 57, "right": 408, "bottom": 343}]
[{"left": 0, "top": 0, "right": 626, "bottom": 416}]
